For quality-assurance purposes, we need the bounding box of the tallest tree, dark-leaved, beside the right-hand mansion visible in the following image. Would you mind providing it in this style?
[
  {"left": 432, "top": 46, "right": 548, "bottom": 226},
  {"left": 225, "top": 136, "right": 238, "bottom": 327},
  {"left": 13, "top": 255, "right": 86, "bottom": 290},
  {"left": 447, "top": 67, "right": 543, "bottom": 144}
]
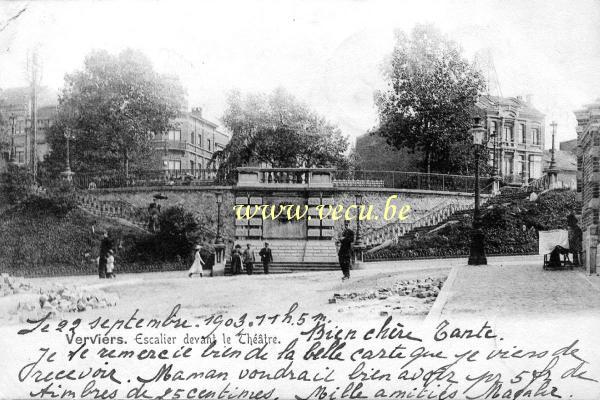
[{"left": 374, "top": 25, "right": 485, "bottom": 173}]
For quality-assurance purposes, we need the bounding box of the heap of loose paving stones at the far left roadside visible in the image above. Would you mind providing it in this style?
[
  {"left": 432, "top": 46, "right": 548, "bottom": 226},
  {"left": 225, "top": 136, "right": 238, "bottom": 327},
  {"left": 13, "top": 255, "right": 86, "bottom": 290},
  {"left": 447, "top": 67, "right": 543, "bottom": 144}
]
[{"left": 18, "top": 285, "right": 117, "bottom": 315}]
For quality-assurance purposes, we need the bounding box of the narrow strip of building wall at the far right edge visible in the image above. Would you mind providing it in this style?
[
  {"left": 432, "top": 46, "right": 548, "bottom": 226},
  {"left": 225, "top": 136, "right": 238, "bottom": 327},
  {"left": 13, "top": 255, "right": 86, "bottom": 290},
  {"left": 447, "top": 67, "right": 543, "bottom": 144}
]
[{"left": 575, "top": 99, "right": 600, "bottom": 273}]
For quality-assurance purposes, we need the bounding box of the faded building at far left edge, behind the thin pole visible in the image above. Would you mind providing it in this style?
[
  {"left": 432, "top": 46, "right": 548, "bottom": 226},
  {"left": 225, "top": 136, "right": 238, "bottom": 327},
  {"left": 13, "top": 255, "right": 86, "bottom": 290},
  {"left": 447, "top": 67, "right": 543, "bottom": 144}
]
[{"left": 0, "top": 87, "right": 57, "bottom": 170}]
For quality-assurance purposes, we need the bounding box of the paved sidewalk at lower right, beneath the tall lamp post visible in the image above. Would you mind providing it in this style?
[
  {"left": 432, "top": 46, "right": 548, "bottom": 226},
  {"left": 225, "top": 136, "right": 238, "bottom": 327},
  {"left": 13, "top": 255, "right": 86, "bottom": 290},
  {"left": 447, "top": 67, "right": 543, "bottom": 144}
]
[{"left": 438, "top": 257, "right": 600, "bottom": 317}]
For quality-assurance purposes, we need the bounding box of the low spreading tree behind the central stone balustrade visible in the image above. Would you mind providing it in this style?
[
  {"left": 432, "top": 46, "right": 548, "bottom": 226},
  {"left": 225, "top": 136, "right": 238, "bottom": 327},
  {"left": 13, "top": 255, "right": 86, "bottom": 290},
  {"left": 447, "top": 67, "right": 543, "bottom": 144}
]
[{"left": 214, "top": 89, "right": 348, "bottom": 178}]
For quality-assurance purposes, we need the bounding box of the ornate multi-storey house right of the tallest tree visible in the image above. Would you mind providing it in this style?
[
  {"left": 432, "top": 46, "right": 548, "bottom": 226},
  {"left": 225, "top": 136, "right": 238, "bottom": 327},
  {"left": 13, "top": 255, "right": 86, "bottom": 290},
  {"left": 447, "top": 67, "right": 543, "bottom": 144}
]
[{"left": 477, "top": 96, "right": 544, "bottom": 185}]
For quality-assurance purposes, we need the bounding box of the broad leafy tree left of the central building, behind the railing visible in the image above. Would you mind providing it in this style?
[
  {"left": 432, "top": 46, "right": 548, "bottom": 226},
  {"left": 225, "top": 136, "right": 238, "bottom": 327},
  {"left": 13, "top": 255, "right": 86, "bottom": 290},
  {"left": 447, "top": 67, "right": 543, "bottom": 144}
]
[{"left": 48, "top": 49, "right": 185, "bottom": 175}]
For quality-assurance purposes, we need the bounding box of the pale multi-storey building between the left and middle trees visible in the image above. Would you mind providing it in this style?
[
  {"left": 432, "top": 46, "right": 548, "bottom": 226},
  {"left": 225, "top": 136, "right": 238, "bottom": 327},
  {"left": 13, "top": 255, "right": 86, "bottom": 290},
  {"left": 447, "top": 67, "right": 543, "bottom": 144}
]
[{"left": 154, "top": 107, "right": 231, "bottom": 174}]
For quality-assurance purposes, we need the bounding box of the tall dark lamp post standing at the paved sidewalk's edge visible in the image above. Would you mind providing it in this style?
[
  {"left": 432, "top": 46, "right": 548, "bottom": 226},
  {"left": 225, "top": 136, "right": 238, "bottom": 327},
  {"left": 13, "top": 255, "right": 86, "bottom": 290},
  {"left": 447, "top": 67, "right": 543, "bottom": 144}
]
[{"left": 469, "top": 118, "right": 487, "bottom": 265}]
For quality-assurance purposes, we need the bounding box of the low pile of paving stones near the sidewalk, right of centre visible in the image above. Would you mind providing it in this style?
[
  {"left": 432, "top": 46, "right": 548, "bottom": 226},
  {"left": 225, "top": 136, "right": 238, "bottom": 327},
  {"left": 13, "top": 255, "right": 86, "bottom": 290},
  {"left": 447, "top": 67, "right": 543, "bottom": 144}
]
[{"left": 329, "top": 278, "right": 446, "bottom": 303}]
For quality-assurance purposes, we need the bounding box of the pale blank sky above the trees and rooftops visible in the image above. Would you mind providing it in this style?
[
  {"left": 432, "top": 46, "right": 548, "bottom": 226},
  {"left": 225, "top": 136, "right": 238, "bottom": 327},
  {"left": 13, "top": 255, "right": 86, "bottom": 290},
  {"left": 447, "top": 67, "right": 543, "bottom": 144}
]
[{"left": 0, "top": 0, "right": 600, "bottom": 147}]
